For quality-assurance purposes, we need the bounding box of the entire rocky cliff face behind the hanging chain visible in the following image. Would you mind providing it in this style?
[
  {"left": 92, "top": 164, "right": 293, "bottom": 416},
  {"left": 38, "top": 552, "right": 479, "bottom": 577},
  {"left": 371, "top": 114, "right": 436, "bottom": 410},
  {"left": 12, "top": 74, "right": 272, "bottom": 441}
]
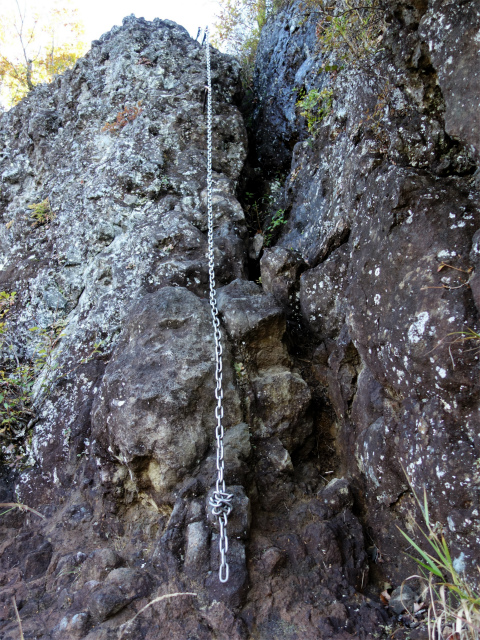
[{"left": 0, "top": 0, "right": 480, "bottom": 640}]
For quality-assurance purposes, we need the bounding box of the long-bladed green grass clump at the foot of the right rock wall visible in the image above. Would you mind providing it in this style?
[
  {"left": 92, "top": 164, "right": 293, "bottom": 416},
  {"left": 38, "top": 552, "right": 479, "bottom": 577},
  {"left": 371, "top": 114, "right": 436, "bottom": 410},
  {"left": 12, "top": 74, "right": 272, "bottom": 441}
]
[{"left": 399, "top": 489, "right": 480, "bottom": 640}]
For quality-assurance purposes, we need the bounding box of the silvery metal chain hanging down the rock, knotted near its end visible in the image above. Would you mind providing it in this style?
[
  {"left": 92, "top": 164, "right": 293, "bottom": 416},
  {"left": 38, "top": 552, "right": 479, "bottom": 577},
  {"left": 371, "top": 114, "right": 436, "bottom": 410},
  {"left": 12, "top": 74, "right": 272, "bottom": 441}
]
[{"left": 205, "top": 27, "right": 233, "bottom": 582}]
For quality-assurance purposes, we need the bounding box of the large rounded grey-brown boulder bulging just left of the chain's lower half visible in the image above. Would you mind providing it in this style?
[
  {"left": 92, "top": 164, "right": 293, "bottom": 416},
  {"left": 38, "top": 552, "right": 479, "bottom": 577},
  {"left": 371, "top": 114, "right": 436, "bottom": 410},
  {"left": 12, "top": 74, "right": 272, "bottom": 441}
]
[{"left": 92, "top": 287, "right": 242, "bottom": 499}]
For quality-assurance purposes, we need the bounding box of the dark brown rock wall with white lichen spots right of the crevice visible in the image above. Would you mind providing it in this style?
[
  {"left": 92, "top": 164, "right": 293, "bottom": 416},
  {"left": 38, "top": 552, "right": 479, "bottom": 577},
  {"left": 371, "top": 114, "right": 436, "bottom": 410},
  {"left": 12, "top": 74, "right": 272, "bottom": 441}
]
[{"left": 255, "top": 0, "right": 480, "bottom": 600}]
